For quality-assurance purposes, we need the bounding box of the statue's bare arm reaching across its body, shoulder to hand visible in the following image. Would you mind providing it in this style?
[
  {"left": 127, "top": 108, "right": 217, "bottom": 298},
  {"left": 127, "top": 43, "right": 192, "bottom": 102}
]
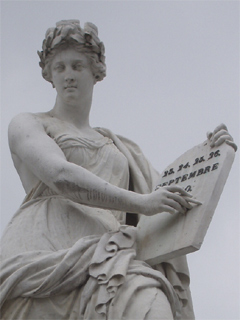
[{"left": 9, "top": 114, "right": 193, "bottom": 215}]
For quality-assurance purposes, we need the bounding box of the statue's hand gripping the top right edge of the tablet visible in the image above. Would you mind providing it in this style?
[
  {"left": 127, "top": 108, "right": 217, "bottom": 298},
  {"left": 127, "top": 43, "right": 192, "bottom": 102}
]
[{"left": 207, "top": 123, "right": 237, "bottom": 151}]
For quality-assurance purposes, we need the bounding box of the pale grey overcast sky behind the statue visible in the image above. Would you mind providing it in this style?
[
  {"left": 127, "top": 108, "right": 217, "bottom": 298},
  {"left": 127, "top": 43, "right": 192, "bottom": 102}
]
[{"left": 1, "top": 1, "right": 240, "bottom": 320}]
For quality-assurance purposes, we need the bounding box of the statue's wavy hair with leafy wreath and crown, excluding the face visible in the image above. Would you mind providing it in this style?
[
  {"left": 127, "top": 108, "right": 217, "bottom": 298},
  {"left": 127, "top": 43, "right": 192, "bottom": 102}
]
[{"left": 38, "top": 20, "right": 106, "bottom": 83}]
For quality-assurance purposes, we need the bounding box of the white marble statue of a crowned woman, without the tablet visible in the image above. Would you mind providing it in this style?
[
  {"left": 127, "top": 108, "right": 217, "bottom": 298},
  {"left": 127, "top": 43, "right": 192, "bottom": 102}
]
[{"left": 1, "top": 20, "right": 236, "bottom": 320}]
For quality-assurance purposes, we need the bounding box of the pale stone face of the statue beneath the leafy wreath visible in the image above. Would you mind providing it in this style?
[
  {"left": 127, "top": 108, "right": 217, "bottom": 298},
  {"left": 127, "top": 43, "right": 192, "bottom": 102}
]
[{"left": 51, "top": 49, "right": 94, "bottom": 102}]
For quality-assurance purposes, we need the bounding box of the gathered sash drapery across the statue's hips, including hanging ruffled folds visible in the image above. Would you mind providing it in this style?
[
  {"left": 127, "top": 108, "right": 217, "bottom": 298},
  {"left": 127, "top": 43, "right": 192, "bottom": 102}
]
[{"left": 1, "top": 226, "right": 180, "bottom": 319}]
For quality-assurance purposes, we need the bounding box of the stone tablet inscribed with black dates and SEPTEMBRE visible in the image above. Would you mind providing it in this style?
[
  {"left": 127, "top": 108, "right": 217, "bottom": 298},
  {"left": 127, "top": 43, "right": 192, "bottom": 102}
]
[{"left": 137, "top": 140, "right": 235, "bottom": 265}]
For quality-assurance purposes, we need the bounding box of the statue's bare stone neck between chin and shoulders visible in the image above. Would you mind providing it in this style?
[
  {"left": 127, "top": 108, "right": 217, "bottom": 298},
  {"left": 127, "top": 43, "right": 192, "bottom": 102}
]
[{"left": 50, "top": 96, "right": 92, "bottom": 129}]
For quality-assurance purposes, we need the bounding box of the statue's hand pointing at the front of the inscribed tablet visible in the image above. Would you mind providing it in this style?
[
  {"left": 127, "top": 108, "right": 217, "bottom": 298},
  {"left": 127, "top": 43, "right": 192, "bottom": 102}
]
[{"left": 143, "top": 186, "right": 201, "bottom": 216}]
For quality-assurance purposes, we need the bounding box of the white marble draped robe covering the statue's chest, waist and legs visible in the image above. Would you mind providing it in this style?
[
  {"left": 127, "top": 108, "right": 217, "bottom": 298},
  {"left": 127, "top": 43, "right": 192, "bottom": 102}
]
[{"left": 1, "top": 128, "right": 194, "bottom": 320}]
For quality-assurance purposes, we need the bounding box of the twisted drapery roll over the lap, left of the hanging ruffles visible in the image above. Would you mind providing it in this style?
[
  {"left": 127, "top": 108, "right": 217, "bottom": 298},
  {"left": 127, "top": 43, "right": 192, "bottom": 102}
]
[{"left": 1, "top": 236, "right": 99, "bottom": 306}]
